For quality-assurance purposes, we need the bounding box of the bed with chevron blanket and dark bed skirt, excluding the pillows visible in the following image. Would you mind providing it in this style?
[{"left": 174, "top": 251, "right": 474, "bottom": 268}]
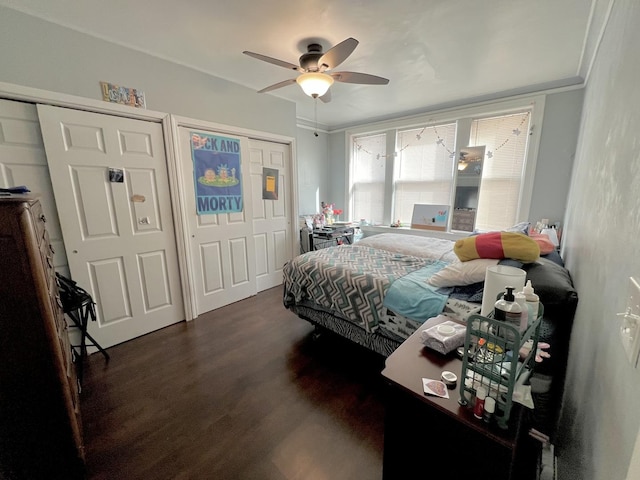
[{"left": 284, "top": 234, "right": 455, "bottom": 356}]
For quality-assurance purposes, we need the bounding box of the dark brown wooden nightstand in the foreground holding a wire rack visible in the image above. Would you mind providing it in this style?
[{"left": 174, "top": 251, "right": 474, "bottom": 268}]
[{"left": 382, "top": 329, "right": 540, "bottom": 480}]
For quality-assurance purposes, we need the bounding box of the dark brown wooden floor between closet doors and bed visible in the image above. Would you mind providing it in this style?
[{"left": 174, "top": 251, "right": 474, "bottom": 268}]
[{"left": 81, "top": 287, "right": 384, "bottom": 480}]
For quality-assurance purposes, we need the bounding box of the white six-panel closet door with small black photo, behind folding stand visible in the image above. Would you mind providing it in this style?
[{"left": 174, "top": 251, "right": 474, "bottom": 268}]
[{"left": 38, "top": 105, "right": 184, "bottom": 347}]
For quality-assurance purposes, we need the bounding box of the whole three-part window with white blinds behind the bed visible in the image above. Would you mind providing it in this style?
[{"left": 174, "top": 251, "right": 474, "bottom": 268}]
[{"left": 348, "top": 97, "right": 544, "bottom": 231}]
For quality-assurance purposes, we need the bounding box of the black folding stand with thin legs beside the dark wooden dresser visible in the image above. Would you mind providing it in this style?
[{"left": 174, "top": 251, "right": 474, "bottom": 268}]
[{"left": 56, "top": 272, "right": 110, "bottom": 389}]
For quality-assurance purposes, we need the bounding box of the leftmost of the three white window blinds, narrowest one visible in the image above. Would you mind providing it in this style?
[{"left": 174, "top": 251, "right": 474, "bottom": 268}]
[{"left": 350, "top": 133, "right": 387, "bottom": 224}]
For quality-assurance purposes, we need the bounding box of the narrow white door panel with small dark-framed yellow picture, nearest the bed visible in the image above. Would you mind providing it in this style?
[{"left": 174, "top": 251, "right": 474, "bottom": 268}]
[{"left": 249, "top": 139, "right": 293, "bottom": 292}]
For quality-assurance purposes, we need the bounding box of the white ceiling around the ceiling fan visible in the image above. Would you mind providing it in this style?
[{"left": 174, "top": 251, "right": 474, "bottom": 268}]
[{"left": 0, "top": 0, "right": 608, "bottom": 130}]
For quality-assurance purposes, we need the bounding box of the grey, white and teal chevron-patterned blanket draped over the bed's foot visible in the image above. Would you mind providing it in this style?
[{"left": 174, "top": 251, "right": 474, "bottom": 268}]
[{"left": 284, "top": 244, "right": 448, "bottom": 332}]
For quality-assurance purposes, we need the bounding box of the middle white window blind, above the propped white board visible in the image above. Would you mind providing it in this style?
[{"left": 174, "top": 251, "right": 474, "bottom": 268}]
[{"left": 393, "top": 123, "right": 456, "bottom": 224}]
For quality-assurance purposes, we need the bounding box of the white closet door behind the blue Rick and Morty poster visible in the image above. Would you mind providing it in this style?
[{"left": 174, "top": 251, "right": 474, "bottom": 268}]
[{"left": 179, "top": 127, "right": 256, "bottom": 315}]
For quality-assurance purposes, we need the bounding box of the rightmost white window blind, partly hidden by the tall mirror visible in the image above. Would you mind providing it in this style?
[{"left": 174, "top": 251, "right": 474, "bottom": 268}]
[{"left": 469, "top": 112, "right": 530, "bottom": 231}]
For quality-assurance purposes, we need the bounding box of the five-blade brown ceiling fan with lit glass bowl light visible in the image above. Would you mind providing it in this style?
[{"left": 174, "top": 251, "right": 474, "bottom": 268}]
[{"left": 242, "top": 38, "right": 389, "bottom": 102}]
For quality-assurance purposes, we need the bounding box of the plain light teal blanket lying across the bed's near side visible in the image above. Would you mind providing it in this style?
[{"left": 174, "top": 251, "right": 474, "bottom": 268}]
[{"left": 383, "top": 261, "right": 451, "bottom": 322}]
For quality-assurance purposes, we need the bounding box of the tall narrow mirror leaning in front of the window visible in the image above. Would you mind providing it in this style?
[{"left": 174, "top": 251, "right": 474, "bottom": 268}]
[{"left": 451, "top": 146, "right": 485, "bottom": 232}]
